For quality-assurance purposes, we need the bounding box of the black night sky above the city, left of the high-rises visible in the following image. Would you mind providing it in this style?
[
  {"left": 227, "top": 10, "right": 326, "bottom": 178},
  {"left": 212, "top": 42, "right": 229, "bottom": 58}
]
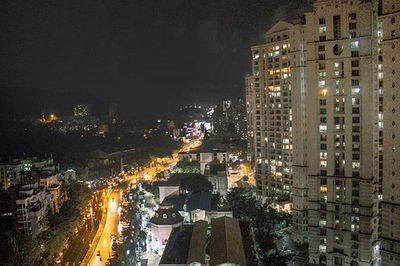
[{"left": 0, "top": 0, "right": 310, "bottom": 116}]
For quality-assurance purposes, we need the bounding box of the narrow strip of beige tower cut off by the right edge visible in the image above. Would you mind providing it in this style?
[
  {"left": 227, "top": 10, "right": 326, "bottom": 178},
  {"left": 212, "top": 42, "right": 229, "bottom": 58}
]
[{"left": 380, "top": 0, "right": 400, "bottom": 266}]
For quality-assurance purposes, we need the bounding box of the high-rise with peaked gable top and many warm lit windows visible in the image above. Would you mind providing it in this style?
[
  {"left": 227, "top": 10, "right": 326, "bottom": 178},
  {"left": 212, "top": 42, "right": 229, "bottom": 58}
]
[{"left": 246, "top": 21, "right": 293, "bottom": 198}]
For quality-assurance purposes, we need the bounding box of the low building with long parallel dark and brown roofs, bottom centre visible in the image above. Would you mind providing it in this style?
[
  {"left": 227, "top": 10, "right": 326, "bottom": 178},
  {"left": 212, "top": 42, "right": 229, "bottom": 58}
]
[{"left": 159, "top": 217, "right": 254, "bottom": 266}]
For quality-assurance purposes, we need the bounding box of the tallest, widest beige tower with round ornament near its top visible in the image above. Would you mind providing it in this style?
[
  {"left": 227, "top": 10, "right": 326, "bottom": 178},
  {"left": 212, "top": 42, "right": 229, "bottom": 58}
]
[{"left": 304, "top": 0, "right": 379, "bottom": 266}]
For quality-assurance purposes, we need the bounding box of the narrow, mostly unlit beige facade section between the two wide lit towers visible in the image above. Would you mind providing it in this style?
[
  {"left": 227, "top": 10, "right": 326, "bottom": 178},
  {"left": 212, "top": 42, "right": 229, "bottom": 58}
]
[{"left": 289, "top": 17, "right": 308, "bottom": 243}]
